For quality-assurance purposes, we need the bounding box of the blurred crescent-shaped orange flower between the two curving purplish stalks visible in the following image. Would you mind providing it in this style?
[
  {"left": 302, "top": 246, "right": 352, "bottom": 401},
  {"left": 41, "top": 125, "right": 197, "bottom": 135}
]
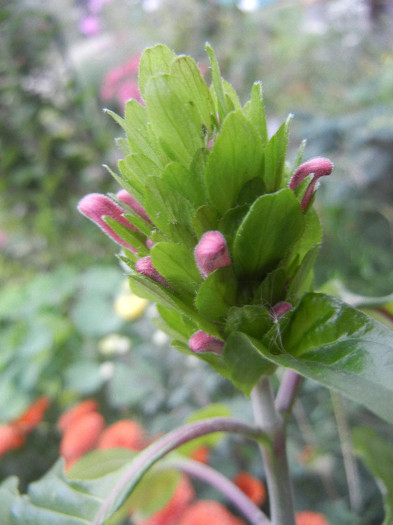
[{"left": 138, "top": 476, "right": 195, "bottom": 525}]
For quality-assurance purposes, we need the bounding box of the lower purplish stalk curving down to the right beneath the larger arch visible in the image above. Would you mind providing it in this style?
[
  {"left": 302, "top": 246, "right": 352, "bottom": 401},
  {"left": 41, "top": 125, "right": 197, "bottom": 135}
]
[{"left": 165, "top": 459, "right": 270, "bottom": 525}]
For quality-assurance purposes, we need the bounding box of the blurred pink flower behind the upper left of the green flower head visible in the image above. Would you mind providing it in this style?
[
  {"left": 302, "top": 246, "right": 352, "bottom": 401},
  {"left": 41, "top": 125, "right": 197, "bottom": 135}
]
[{"left": 101, "top": 54, "right": 142, "bottom": 107}]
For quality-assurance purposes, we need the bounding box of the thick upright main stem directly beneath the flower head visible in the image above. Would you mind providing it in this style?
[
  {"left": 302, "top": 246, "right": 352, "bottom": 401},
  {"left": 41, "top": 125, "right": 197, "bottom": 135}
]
[{"left": 251, "top": 377, "right": 295, "bottom": 525}]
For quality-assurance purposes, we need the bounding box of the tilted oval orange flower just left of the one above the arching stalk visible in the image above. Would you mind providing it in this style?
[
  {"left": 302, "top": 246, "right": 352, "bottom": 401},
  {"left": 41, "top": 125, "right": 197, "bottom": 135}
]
[{"left": 60, "top": 412, "right": 105, "bottom": 464}]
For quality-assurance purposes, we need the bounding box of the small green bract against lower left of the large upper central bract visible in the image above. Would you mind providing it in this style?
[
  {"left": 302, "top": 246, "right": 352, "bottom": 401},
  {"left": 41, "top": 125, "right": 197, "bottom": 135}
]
[{"left": 162, "top": 162, "right": 207, "bottom": 209}]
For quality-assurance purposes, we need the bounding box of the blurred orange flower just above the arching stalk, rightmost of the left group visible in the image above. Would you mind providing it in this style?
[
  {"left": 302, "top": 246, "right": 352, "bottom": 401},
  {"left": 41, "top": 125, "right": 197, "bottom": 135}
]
[{"left": 97, "top": 419, "right": 147, "bottom": 450}]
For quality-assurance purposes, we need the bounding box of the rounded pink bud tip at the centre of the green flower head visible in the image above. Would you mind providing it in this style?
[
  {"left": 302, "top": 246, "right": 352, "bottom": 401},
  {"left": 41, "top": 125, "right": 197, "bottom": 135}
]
[{"left": 194, "top": 231, "right": 232, "bottom": 279}]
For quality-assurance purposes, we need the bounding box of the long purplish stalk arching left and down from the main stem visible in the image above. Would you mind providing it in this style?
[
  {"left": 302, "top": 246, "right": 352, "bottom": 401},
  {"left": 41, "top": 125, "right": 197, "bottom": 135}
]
[{"left": 92, "top": 417, "right": 268, "bottom": 525}]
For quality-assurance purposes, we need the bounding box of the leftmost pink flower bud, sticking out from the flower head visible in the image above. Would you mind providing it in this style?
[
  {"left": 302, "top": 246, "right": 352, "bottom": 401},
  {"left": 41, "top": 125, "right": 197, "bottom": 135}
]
[{"left": 78, "top": 193, "right": 137, "bottom": 252}]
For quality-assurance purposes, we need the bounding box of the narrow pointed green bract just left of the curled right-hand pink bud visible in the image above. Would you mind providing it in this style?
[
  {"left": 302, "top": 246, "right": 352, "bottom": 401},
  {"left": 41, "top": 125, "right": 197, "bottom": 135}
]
[{"left": 262, "top": 115, "right": 292, "bottom": 193}]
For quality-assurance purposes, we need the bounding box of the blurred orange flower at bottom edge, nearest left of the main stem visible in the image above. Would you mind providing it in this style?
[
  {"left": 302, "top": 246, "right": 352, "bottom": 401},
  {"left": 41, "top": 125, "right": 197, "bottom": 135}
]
[{"left": 177, "top": 500, "right": 244, "bottom": 525}]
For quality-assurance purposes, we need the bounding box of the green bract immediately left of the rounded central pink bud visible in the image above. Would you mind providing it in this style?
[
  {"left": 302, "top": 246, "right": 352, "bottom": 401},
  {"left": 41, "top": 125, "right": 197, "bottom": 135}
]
[{"left": 151, "top": 242, "right": 202, "bottom": 295}]
